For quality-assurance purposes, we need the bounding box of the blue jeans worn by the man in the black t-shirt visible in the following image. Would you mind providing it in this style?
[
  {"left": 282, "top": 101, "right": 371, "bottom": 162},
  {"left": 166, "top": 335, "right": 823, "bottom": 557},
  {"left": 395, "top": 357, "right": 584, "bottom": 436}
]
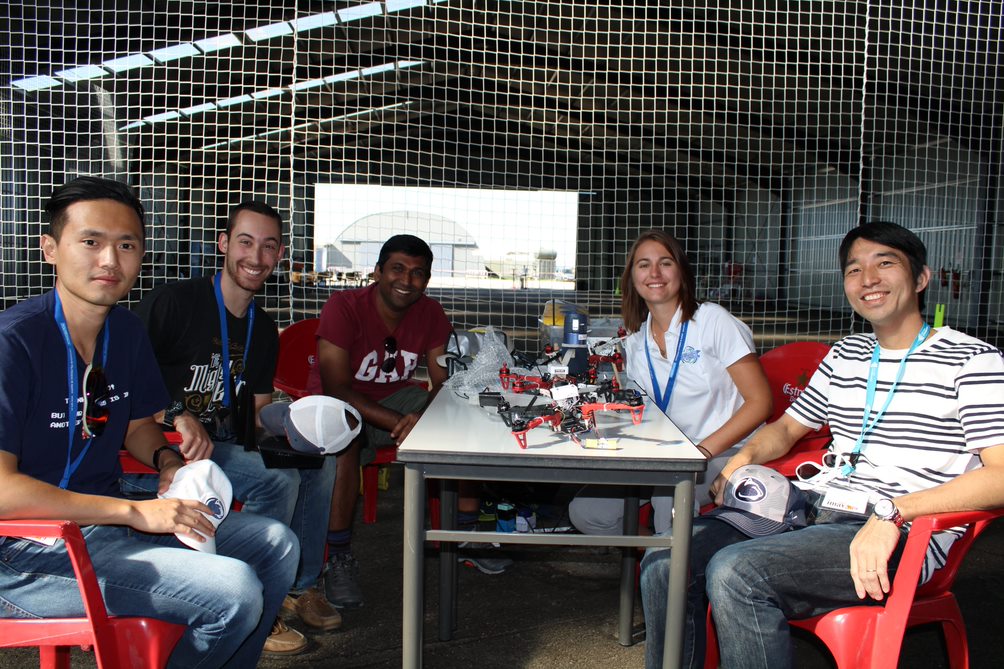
[{"left": 121, "top": 441, "right": 336, "bottom": 592}]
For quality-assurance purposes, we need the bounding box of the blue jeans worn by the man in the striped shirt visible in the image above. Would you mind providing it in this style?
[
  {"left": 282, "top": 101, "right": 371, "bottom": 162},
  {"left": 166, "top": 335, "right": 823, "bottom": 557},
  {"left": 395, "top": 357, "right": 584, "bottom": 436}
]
[{"left": 642, "top": 512, "right": 906, "bottom": 669}]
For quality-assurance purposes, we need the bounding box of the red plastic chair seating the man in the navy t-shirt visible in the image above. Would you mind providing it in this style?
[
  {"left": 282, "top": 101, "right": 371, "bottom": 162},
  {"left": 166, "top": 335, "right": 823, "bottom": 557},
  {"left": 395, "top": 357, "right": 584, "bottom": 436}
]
[{"left": 0, "top": 520, "right": 186, "bottom": 669}]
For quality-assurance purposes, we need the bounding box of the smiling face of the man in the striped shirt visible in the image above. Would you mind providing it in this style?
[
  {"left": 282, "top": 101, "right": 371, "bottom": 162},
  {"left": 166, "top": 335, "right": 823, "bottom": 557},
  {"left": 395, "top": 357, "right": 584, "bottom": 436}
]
[{"left": 843, "top": 238, "right": 931, "bottom": 335}]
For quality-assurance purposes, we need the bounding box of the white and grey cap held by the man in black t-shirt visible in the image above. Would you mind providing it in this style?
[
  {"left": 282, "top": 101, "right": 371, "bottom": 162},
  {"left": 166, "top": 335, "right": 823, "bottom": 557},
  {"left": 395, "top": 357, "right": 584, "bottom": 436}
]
[{"left": 258, "top": 395, "right": 362, "bottom": 455}]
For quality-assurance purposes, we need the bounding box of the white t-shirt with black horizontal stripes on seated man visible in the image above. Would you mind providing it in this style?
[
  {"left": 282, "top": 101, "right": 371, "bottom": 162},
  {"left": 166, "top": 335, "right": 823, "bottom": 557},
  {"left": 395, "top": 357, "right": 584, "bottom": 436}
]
[{"left": 787, "top": 327, "right": 1004, "bottom": 580}]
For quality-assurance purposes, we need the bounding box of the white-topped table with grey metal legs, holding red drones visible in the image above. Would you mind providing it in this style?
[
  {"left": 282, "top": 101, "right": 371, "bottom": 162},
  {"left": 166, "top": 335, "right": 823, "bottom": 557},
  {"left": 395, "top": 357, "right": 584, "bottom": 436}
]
[{"left": 398, "top": 389, "right": 707, "bottom": 669}]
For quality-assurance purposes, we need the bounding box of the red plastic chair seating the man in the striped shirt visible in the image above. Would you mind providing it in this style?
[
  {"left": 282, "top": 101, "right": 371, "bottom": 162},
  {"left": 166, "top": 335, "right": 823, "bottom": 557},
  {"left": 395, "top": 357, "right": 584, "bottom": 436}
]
[{"left": 704, "top": 509, "right": 1004, "bottom": 669}]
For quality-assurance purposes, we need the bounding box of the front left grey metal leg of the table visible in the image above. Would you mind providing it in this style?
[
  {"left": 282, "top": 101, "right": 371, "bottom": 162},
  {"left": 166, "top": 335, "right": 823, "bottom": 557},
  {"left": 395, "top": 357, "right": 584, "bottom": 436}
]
[{"left": 401, "top": 465, "right": 426, "bottom": 669}]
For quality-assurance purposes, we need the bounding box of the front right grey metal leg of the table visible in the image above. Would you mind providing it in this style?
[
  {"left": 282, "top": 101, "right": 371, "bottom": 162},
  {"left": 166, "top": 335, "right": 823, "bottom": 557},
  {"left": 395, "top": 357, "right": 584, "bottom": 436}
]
[{"left": 663, "top": 477, "right": 703, "bottom": 669}]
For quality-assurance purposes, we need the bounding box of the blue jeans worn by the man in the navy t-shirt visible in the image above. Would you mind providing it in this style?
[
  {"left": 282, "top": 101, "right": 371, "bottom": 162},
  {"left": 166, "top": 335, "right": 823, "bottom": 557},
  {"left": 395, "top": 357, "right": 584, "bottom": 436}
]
[{"left": 0, "top": 513, "right": 299, "bottom": 669}]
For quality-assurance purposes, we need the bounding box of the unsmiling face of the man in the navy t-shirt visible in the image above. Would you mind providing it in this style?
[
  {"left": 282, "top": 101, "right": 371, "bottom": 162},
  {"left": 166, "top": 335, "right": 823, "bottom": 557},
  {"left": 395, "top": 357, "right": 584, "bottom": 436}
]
[{"left": 42, "top": 200, "right": 144, "bottom": 309}]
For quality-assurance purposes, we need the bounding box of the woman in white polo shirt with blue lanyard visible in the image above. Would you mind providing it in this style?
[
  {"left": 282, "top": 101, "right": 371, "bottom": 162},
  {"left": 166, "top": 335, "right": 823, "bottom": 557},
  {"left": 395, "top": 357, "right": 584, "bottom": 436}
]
[{"left": 568, "top": 230, "right": 772, "bottom": 534}]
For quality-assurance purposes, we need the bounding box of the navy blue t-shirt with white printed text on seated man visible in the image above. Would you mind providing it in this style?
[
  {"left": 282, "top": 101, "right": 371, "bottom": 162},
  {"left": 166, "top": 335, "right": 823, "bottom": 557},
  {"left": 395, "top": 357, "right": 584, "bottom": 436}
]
[{"left": 0, "top": 291, "right": 169, "bottom": 496}]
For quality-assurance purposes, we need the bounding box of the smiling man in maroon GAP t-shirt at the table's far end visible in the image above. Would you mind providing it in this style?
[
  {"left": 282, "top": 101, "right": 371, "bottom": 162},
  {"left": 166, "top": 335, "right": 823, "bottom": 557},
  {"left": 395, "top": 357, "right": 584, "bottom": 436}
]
[{"left": 307, "top": 235, "right": 511, "bottom": 609}]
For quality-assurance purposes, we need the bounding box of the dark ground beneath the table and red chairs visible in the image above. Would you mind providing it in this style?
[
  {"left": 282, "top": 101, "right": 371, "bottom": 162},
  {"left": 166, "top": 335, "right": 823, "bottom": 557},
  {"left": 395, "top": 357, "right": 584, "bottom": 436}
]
[{"left": 0, "top": 465, "right": 1004, "bottom": 669}]
